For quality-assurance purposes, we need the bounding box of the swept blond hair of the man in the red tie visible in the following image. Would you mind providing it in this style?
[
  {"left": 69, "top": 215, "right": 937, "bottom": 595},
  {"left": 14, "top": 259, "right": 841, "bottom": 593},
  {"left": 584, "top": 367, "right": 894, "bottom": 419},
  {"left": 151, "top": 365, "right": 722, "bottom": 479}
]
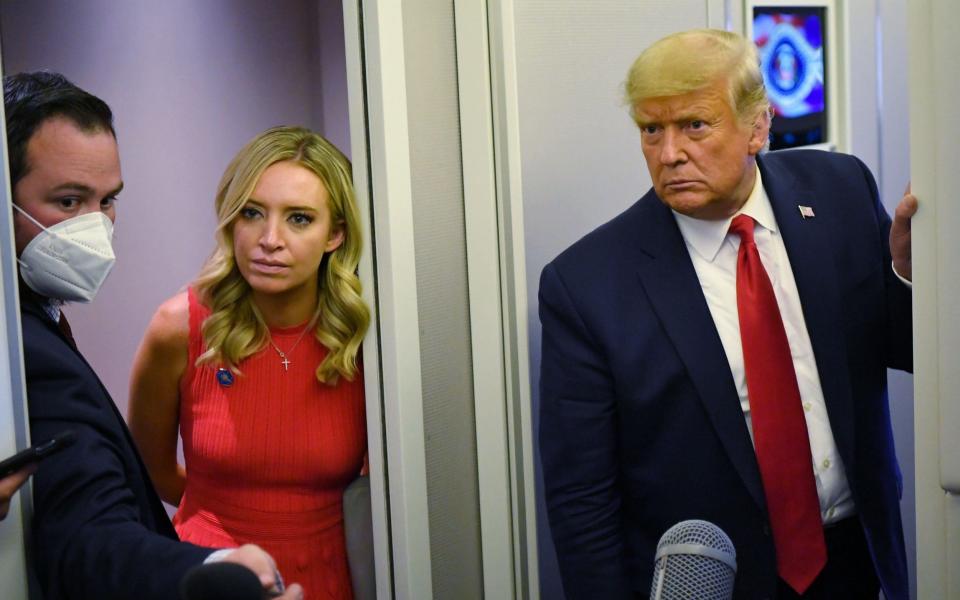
[{"left": 624, "top": 29, "right": 770, "bottom": 125}]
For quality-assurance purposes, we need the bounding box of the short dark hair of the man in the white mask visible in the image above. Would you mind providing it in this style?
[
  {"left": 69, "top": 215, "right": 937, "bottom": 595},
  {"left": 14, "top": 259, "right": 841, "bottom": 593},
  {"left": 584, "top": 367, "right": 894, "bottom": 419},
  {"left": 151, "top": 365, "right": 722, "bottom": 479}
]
[{"left": 3, "top": 71, "right": 117, "bottom": 187}]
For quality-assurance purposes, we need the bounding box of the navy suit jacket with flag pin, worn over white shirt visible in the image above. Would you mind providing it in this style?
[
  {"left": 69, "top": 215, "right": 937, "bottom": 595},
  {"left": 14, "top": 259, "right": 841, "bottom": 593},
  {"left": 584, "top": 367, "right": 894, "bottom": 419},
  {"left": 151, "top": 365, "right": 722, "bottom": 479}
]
[{"left": 540, "top": 151, "right": 912, "bottom": 600}]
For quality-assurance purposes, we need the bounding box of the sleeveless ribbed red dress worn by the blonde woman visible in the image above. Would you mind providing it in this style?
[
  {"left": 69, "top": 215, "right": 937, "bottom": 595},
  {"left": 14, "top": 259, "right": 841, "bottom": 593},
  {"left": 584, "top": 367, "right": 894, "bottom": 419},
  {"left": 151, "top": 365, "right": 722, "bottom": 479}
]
[{"left": 173, "top": 289, "right": 366, "bottom": 600}]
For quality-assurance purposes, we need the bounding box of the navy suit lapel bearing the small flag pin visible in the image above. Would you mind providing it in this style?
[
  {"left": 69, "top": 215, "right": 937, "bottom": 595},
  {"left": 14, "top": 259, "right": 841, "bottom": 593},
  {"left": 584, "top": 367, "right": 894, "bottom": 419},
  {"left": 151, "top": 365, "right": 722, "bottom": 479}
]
[{"left": 759, "top": 154, "right": 854, "bottom": 473}]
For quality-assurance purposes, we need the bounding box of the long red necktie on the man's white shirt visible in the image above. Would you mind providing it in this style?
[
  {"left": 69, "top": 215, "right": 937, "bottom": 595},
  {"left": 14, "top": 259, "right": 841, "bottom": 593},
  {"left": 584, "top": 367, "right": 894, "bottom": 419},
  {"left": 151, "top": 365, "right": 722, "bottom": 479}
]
[{"left": 730, "top": 215, "right": 827, "bottom": 594}]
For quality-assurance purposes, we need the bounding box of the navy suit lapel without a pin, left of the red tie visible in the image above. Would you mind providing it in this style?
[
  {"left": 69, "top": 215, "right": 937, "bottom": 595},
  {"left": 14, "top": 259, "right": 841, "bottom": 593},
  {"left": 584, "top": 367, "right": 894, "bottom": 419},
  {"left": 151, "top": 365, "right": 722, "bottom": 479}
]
[{"left": 636, "top": 196, "right": 766, "bottom": 510}]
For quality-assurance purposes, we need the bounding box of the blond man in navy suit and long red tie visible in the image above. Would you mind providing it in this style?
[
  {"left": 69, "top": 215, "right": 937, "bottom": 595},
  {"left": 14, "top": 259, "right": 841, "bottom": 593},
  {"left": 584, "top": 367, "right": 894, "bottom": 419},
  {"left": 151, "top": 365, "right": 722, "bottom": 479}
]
[{"left": 540, "top": 30, "right": 916, "bottom": 599}]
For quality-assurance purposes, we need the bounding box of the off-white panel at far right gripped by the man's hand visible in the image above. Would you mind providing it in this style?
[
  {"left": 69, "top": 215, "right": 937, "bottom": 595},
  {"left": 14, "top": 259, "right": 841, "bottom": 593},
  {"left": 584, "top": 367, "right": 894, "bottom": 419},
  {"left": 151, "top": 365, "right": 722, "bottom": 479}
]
[{"left": 907, "top": 0, "right": 960, "bottom": 599}]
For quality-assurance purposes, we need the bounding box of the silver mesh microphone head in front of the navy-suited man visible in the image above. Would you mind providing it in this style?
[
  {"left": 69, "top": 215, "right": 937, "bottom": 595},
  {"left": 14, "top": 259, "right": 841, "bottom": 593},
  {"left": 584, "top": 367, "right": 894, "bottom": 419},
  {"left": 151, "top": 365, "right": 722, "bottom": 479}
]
[{"left": 650, "top": 519, "right": 737, "bottom": 600}]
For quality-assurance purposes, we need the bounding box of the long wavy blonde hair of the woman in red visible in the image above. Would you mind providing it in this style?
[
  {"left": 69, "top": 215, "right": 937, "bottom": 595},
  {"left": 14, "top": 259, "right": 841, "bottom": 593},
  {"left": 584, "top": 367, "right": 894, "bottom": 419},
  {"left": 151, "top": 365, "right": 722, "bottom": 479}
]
[{"left": 193, "top": 127, "right": 370, "bottom": 385}]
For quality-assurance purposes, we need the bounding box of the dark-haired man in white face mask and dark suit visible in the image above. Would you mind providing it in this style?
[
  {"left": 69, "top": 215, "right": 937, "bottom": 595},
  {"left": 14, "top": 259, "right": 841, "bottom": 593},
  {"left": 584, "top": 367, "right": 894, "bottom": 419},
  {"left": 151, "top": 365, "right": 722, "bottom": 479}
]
[{"left": 4, "top": 73, "right": 300, "bottom": 600}]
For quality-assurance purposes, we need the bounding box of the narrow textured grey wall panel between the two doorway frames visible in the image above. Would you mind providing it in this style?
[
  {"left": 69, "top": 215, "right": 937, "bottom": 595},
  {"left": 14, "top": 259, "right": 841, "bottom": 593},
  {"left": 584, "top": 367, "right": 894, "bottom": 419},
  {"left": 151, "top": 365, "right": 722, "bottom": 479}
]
[{"left": 400, "top": 0, "right": 484, "bottom": 600}]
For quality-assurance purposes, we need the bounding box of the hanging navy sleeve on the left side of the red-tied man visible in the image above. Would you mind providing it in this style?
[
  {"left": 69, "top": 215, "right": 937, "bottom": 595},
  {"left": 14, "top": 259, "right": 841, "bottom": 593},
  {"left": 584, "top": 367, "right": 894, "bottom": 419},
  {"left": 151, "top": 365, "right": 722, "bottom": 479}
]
[{"left": 540, "top": 264, "right": 629, "bottom": 600}]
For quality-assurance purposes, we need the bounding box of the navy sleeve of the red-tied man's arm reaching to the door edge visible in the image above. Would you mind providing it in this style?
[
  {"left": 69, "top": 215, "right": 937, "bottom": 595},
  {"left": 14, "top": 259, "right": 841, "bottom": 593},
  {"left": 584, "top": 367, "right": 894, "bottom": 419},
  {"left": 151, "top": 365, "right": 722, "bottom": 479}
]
[{"left": 854, "top": 158, "right": 913, "bottom": 373}]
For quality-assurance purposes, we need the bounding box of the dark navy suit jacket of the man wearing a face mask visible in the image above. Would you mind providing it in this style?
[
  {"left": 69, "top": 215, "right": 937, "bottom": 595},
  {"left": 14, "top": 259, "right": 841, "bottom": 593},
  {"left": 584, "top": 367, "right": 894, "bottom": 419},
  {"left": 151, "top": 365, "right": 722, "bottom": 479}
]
[{"left": 21, "top": 290, "right": 212, "bottom": 600}]
